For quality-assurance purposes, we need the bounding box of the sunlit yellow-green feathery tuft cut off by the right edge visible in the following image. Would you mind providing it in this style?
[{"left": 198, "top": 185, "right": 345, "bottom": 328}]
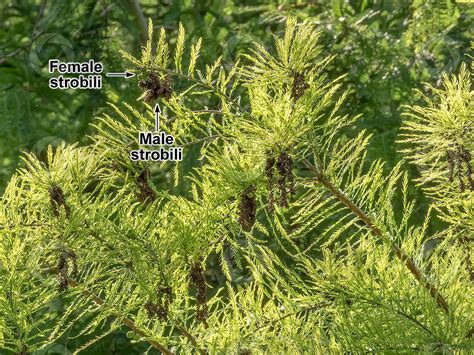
[{"left": 401, "top": 65, "right": 474, "bottom": 288}]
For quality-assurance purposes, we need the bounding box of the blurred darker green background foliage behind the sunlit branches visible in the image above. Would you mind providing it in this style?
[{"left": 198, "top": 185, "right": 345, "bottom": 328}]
[{"left": 0, "top": 0, "right": 474, "bottom": 354}]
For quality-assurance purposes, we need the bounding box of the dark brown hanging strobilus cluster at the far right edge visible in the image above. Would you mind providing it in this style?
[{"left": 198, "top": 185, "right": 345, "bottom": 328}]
[{"left": 447, "top": 144, "right": 474, "bottom": 192}]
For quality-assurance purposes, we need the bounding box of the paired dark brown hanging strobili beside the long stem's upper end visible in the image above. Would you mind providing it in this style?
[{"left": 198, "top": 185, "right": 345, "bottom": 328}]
[{"left": 265, "top": 152, "right": 295, "bottom": 212}]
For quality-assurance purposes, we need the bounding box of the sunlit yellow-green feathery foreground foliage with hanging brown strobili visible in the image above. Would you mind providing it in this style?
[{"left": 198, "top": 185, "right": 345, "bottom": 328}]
[{"left": 0, "top": 1, "right": 474, "bottom": 354}]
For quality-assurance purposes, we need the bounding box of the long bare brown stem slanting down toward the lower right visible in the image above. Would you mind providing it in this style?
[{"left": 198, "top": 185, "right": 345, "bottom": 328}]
[{"left": 305, "top": 161, "right": 449, "bottom": 313}]
